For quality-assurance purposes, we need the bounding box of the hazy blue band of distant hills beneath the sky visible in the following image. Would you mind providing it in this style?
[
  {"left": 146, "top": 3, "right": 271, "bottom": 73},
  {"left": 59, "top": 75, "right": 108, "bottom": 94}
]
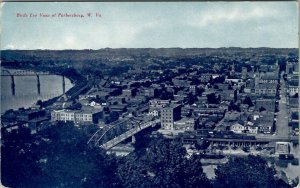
[{"left": 1, "top": 47, "right": 298, "bottom": 62}]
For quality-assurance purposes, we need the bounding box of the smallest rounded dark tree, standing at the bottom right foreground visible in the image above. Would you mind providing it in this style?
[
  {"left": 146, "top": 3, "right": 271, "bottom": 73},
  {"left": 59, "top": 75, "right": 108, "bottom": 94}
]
[{"left": 215, "top": 155, "right": 289, "bottom": 188}]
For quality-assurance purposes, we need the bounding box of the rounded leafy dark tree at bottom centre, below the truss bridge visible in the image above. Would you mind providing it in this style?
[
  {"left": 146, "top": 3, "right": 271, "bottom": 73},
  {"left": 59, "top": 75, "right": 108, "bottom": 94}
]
[{"left": 118, "top": 138, "right": 211, "bottom": 187}]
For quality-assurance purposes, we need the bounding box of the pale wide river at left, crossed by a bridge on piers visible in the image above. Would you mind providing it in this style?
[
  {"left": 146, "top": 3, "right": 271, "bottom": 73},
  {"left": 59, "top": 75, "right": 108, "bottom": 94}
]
[{"left": 1, "top": 68, "right": 73, "bottom": 113}]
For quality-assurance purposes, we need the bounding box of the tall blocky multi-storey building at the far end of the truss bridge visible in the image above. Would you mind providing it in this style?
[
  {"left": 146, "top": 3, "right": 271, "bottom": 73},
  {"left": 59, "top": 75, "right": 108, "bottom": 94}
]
[{"left": 161, "top": 104, "right": 181, "bottom": 130}]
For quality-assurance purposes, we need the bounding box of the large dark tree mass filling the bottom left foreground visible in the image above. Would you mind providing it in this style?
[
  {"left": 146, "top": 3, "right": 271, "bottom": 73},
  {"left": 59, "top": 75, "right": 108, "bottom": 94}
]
[{"left": 1, "top": 122, "right": 120, "bottom": 187}]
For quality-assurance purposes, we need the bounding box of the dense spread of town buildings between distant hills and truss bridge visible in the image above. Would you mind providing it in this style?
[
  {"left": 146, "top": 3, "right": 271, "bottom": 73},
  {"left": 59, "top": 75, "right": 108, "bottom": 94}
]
[{"left": 1, "top": 53, "right": 299, "bottom": 143}]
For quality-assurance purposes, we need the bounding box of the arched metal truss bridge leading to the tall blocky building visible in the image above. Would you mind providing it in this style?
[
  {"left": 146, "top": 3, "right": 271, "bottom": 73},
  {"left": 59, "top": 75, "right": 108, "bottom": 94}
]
[{"left": 88, "top": 118, "right": 160, "bottom": 150}]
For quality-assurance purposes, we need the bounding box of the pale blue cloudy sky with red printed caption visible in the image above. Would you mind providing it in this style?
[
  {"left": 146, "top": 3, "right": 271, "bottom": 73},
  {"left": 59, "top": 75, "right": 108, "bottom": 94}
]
[{"left": 0, "top": 1, "right": 298, "bottom": 50}]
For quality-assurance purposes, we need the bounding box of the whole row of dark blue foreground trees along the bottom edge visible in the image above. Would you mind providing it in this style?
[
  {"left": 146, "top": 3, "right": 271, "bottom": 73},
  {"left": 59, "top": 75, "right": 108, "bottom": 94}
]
[{"left": 1, "top": 122, "right": 289, "bottom": 188}]
